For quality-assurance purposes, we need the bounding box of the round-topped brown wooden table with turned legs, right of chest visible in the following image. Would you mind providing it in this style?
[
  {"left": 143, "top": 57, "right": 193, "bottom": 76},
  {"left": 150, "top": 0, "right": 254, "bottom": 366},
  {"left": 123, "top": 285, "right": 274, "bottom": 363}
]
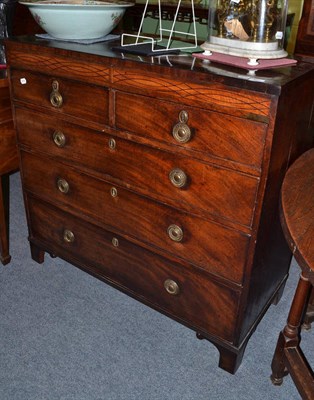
[{"left": 271, "top": 148, "right": 314, "bottom": 400}]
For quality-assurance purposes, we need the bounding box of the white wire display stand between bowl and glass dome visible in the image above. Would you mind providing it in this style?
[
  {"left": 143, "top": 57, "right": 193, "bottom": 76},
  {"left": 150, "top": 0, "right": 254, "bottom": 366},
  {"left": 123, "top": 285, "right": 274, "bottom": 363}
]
[{"left": 121, "top": 0, "right": 197, "bottom": 54}]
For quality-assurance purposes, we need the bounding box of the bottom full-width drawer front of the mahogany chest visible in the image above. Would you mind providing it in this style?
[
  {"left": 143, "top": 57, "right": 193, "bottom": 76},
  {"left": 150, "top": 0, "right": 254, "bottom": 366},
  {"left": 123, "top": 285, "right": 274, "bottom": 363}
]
[{"left": 28, "top": 197, "right": 239, "bottom": 341}]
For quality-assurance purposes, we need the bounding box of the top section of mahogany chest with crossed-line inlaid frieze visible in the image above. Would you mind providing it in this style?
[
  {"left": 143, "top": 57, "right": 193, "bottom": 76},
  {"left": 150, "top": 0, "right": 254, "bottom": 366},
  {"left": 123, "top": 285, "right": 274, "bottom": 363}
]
[{"left": 6, "top": 37, "right": 313, "bottom": 115}]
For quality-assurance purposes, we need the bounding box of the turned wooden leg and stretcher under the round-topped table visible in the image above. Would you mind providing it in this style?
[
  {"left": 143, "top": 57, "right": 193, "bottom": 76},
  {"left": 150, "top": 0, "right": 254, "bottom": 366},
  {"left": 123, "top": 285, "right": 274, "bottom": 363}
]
[{"left": 271, "top": 274, "right": 314, "bottom": 400}]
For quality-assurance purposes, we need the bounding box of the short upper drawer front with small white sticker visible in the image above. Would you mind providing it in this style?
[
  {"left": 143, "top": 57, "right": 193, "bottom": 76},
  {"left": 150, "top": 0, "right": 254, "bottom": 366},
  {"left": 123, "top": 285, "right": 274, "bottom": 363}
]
[{"left": 11, "top": 69, "right": 109, "bottom": 125}]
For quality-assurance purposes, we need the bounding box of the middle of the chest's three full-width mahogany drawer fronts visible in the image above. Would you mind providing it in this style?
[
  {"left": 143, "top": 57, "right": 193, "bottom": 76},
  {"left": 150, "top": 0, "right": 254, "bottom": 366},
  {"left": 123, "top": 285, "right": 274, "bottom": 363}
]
[{"left": 21, "top": 152, "right": 249, "bottom": 283}]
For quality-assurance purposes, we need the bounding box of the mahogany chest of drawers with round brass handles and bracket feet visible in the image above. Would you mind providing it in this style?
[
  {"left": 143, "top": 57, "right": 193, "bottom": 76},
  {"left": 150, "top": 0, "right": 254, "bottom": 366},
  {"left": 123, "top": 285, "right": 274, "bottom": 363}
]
[{"left": 6, "top": 37, "right": 314, "bottom": 373}]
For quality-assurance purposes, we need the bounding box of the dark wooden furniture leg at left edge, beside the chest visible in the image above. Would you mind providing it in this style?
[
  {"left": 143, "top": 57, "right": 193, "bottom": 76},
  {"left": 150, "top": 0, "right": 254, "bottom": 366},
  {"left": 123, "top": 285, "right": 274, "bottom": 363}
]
[{"left": 0, "top": 174, "right": 11, "bottom": 265}]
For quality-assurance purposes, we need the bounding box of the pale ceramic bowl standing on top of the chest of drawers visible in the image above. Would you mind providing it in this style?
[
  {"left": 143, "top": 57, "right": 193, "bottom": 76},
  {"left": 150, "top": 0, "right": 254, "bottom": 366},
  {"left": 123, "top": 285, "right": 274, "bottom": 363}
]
[{"left": 20, "top": 0, "right": 134, "bottom": 39}]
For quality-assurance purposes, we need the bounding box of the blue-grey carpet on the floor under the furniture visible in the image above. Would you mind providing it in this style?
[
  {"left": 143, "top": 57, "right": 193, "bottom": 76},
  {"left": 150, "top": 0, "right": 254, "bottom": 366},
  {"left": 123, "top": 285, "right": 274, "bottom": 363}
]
[{"left": 0, "top": 173, "right": 314, "bottom": 400}]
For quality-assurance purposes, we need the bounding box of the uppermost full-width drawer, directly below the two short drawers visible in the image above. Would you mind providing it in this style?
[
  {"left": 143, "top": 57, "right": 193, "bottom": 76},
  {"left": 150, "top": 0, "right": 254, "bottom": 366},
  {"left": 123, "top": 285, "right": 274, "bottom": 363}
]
[{"left": 16, "top": 109, "right": 259, "bottom": 227}]
